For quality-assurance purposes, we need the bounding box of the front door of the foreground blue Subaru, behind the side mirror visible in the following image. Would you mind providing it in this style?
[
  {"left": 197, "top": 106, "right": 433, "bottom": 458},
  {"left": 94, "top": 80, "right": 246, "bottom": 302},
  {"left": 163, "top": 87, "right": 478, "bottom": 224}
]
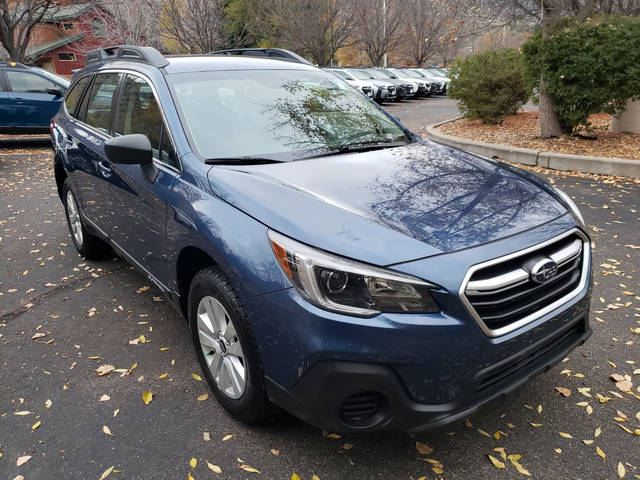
[{"left": 102, "top": 74, "right": 179, "bottom": 283}]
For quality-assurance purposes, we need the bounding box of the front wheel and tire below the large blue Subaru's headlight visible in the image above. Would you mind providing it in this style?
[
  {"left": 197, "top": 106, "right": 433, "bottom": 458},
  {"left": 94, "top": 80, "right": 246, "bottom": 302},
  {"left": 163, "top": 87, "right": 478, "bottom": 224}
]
[{"left": 189, "top": 267, "right": 273, "bottom": 424}]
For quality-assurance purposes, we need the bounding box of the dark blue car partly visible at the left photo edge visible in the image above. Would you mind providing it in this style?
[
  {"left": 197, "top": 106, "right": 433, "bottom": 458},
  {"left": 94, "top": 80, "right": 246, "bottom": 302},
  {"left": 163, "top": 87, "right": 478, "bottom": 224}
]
[{"left": 0, "top": 62, "right": 69, "bottom": 133}]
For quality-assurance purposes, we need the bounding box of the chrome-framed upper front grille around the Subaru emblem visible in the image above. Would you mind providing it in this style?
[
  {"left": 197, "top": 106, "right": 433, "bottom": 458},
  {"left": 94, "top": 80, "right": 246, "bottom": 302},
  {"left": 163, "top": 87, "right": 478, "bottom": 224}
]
[{"left": 464, "top": 231, "right": 588, "bottom": 336}]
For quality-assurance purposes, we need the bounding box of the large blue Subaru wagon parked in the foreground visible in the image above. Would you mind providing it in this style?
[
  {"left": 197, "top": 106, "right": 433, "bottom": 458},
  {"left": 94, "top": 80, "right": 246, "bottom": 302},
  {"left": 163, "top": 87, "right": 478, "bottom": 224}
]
[{"left": 52, "top": 47, "right": 591, "bottom": 431}]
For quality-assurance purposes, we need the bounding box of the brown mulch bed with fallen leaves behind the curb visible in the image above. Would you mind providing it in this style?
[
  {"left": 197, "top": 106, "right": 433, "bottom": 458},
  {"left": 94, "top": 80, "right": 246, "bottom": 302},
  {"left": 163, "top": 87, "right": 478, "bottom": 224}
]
[{"left": 438, "top": 111, "right": 640, "bottom": 160}]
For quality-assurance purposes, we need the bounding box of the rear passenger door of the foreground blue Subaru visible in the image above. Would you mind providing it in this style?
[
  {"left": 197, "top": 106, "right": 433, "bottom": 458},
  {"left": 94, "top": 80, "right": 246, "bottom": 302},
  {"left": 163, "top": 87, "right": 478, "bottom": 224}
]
[{"left": 70, "top": 73, "right": 122, "bottom": 228}]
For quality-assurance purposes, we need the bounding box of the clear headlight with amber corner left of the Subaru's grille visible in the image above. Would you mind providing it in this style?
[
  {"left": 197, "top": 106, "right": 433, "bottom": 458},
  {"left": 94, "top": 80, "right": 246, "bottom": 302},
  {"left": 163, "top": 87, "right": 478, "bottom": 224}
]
[{"left": 269, "top": 231, "right": 440, "bottom": 317}]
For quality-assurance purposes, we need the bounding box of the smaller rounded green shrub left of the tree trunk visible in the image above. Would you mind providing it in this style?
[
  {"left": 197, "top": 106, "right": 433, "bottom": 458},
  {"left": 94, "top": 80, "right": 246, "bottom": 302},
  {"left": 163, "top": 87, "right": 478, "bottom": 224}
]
[{"left": 449, "top": 48, "right": 531, "bottom": 123}]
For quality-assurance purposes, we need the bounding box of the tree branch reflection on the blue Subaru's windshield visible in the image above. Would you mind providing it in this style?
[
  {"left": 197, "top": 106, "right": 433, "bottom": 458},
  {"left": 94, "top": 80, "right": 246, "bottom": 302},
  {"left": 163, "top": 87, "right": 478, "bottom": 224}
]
[{"left": 263, "top": 80, "right": 403, "bottom": 151}]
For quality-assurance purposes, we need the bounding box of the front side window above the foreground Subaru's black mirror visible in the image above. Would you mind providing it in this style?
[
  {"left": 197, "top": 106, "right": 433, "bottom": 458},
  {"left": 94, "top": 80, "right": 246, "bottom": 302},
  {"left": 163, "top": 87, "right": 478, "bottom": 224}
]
[{"left": 114, "top": 75, "right": 178, "bottom": 168}]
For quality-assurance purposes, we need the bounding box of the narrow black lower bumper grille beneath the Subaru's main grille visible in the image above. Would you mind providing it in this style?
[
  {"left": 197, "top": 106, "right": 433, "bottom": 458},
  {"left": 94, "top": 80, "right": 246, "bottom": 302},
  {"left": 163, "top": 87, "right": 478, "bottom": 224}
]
[{"left": 476, "top": 319, "right": 586, "bottom": 393}]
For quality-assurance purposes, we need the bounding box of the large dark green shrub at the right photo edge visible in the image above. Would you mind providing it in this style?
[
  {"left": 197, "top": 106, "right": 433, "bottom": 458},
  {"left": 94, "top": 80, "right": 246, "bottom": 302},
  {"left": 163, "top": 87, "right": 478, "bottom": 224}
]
[{"left": 522, "top": 16, "right": 640, "bottom": 134}]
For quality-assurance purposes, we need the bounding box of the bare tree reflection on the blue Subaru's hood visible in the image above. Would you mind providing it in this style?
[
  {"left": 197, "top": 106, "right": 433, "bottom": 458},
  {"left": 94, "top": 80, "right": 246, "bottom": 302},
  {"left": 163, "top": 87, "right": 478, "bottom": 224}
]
[{"left": 370, "top": 143, "right": 562, "bottom": 249}]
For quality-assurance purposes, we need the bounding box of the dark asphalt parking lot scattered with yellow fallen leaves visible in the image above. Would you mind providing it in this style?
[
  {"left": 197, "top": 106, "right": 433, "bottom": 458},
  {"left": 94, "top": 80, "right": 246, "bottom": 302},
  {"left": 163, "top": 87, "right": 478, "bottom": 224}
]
[{"left": 0, "top": 98, "right": 640, "bottom": 480}]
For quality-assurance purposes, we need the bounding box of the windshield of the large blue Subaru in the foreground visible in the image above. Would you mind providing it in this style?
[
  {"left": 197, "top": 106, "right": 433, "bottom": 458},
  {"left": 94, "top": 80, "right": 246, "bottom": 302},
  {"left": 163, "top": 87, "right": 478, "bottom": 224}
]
[{"left": 168, "top": 70, "right": 410, "bottom": 161}]
